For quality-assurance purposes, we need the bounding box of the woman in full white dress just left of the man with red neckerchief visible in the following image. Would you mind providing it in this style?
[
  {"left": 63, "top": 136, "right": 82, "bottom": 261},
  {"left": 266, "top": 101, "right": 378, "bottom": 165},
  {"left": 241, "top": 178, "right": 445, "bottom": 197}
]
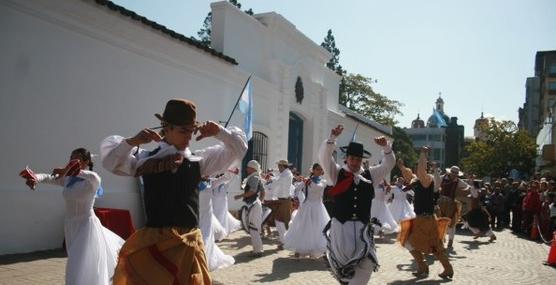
[{"left": 284, "top": 163, "right": 330, "bottom": 258}]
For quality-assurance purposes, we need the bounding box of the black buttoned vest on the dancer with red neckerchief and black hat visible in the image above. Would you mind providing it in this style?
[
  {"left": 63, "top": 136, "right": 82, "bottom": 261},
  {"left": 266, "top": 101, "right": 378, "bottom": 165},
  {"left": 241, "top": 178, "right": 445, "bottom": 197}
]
[{"left": 333, "top": 168, "right": 375, "bottom": 224}]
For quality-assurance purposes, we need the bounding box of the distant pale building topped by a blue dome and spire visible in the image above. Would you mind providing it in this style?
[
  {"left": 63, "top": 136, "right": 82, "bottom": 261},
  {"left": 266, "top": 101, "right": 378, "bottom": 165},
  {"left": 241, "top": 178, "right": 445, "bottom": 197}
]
[{"left": 404, "top": 96, "right": 464, "bottom": 167}]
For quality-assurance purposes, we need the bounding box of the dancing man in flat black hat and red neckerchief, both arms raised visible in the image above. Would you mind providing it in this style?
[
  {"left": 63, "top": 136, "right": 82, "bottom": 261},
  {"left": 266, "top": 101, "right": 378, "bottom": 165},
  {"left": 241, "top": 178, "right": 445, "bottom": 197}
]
[{"left": 319, "top": 125, "right": 396, "bottom": 284}]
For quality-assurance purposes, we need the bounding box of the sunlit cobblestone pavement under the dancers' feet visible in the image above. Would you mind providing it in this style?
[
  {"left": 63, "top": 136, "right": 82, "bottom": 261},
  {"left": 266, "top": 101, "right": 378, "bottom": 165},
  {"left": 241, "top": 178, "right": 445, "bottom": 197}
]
[{"left": 0, "top": 227, "right": 556, "bottom": 285}]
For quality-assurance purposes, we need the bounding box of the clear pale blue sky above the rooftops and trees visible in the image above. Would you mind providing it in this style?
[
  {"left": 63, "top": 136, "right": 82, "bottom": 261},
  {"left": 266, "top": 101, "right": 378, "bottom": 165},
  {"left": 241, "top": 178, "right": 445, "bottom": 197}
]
[{"left": 113, "top": 0, "right": 556, "bottom": 136}]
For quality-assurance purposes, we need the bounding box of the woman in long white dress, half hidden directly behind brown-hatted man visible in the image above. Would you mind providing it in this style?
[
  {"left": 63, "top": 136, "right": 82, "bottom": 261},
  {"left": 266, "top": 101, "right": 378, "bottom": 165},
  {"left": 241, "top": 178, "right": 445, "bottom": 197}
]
[{"left": 199, "top": 180, "right": 235, "bottom": 271}]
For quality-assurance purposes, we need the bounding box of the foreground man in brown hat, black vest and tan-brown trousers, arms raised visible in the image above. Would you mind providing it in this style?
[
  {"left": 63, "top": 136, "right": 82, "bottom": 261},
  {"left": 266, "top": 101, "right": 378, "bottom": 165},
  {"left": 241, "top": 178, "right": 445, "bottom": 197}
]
[{"left": 101, "top": 99, "right": 247, "bottom": 284}]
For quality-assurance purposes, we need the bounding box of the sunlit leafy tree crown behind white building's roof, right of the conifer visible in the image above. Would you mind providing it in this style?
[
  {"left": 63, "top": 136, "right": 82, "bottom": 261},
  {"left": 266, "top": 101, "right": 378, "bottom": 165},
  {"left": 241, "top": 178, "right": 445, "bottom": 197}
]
[{"left": 340, "top": 73, "right": 402, "bottom": 126}]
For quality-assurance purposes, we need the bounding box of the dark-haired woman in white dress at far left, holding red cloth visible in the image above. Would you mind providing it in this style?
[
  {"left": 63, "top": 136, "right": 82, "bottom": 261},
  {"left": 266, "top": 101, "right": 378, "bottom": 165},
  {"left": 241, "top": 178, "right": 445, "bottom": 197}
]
[{"left": 20, "top": 148, "right": 124, "bottom": 285}]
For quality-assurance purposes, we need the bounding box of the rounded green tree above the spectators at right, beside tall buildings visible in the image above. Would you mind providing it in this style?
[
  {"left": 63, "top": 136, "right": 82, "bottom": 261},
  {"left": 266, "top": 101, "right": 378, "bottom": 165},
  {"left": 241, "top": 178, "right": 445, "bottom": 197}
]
[{"left": 462, "top": 119, "right": 537, "bottom": 177}]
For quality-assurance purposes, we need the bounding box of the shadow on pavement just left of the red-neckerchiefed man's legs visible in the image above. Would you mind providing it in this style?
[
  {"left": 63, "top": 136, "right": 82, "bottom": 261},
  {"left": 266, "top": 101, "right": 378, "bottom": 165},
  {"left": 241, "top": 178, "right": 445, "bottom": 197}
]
[{"left": 255, "top": 255, "right": 330, "bottom": 282}]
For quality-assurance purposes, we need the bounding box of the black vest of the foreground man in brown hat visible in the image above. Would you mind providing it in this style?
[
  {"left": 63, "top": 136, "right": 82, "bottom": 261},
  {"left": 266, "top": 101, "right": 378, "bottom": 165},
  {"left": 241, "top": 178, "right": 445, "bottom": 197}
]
[{"left": 142, "top": 152, "right": 201, "bottom": 228}]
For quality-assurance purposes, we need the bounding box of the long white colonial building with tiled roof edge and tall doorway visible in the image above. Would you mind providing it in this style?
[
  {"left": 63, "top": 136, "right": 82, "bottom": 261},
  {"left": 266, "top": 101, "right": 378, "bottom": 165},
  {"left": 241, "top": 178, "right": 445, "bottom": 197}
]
[{"left": 0, "top": 0, "right": 392, "bottom": 254}]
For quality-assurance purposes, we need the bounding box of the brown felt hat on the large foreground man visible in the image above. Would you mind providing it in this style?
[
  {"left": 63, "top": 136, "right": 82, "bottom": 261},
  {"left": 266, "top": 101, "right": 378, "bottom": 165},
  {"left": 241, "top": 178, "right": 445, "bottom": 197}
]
[{"left": 154, "top": 99, "right": 198, "bottom": 126}]
